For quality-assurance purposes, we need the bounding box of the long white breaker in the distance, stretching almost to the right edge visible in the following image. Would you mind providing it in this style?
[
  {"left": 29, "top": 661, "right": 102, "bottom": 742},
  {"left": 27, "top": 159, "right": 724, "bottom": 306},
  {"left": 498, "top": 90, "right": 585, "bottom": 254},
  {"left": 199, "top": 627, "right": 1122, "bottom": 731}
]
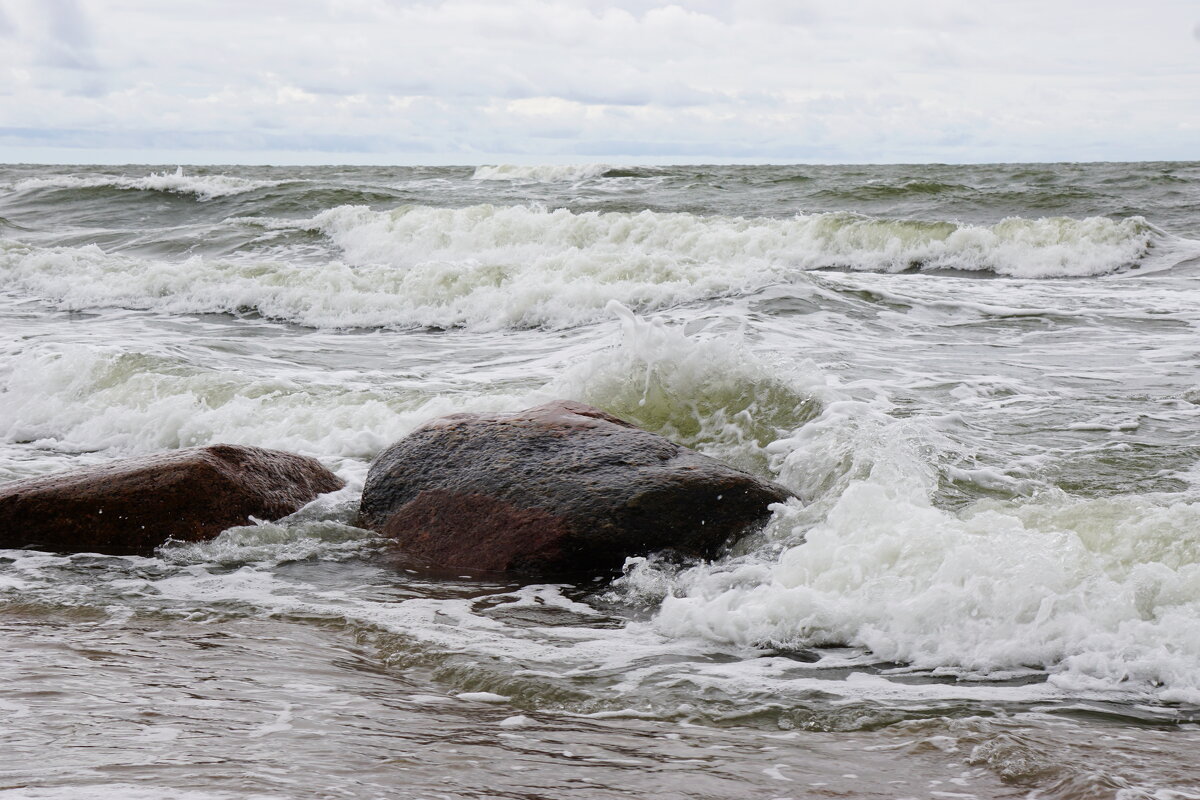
[{"left": 308, "top": 205, "right": 1165, "bottom": 281}]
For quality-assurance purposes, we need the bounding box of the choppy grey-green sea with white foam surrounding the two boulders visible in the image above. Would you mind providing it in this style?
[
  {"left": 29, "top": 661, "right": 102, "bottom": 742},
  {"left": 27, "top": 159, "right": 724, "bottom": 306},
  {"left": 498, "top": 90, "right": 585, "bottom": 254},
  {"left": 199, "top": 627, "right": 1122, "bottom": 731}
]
[{"left": 0, "top": 163, "right": 1200, "bottom": 800}]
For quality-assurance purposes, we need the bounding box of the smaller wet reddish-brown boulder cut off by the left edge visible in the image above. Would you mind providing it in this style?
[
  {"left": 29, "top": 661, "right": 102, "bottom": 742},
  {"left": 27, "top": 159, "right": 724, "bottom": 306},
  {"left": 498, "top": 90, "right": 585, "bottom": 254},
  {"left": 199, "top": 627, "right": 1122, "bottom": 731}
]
[{"left": 0, "top": 445, "right": 343, "bottom": 555}]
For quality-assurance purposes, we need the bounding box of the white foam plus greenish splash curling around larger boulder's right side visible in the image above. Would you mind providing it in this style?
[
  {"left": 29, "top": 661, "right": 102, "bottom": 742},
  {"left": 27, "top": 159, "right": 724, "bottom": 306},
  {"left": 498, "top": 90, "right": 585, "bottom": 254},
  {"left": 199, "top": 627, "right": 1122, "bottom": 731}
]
[{"left": 549, "top": 321, "right": 1200, "bottom": 703}]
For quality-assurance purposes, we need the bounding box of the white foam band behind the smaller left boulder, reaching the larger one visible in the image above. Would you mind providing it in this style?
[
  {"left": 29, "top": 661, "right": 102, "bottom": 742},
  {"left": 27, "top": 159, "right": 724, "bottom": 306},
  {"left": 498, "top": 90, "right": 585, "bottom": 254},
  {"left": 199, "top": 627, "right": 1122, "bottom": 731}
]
[{"left": 0, "top": 344, "right": 530, "bottom": 481}]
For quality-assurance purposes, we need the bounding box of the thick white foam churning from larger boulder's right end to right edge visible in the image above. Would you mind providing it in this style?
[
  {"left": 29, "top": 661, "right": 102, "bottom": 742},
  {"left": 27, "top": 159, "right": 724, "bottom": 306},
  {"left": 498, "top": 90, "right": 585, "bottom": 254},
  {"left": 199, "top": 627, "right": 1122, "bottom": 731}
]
[{"left": 626, "top": 393, "right": 1200, "bottom": 703}]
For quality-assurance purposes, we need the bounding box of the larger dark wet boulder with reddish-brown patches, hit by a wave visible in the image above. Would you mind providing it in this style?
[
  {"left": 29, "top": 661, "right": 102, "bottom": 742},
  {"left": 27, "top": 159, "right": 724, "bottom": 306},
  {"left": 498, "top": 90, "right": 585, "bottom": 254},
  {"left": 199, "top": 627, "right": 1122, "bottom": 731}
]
[{"left": 359, "top": 401, "right": 792, "bottom": 572}]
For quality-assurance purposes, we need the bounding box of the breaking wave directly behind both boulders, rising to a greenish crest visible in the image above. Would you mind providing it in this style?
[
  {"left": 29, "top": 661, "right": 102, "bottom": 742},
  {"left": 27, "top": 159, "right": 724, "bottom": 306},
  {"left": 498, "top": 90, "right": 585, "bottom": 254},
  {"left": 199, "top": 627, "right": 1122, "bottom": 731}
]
[{"left": 0, "top": 303, "right": 824, "bottom": 475}]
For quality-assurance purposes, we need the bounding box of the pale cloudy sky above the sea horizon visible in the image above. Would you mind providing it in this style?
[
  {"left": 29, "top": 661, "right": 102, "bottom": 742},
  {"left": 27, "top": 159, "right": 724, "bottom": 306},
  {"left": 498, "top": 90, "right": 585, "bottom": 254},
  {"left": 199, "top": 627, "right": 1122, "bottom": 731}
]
[{"left": 0, "top": 0, "right": 1200, "bottom": 164}]
